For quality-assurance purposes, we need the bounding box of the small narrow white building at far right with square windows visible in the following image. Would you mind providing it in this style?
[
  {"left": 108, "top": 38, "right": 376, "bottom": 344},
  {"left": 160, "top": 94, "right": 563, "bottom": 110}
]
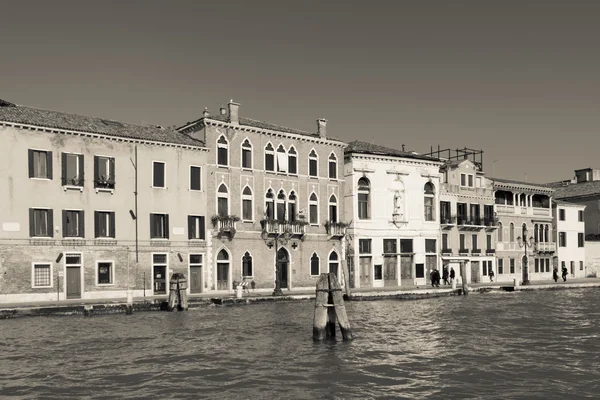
[{"left": 552, "top": 200, "right": 586, "bottom": 278}]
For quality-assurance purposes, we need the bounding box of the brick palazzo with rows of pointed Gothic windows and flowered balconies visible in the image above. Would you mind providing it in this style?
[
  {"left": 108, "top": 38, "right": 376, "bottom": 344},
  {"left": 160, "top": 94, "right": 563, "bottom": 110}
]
[{"left": 178, "top": 101, "right": 346, "bottom": 292}]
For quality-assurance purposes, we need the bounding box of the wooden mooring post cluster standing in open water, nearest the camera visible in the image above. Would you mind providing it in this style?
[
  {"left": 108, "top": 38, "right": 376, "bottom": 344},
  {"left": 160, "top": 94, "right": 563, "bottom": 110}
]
[{"left": 313, "top": 272, "right": 352, "bottom": 341}]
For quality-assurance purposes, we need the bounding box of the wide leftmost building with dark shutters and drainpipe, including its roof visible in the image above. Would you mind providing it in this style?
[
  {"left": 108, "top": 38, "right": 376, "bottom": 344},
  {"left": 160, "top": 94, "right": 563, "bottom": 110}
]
[{"left": 0, "top": 102, "right": 210, "bottom": 302}]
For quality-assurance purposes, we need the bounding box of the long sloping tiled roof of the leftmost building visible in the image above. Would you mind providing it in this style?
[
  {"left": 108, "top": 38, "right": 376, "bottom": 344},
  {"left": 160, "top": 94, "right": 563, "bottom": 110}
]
[{"left": 0, "top": 100, "right": 204, "bottom": 147}]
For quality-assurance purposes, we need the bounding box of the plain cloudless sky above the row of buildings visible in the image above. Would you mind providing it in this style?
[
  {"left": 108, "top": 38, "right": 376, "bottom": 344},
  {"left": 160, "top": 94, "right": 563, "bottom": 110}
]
[{"left": 0, "top": 0, "right": 600, "bottom": 183}]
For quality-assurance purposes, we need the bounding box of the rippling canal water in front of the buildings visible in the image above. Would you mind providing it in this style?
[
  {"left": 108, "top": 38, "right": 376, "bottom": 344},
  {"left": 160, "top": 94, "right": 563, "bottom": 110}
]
[{"left": 0, "top": 289, "right": 600, "bottom": 400}]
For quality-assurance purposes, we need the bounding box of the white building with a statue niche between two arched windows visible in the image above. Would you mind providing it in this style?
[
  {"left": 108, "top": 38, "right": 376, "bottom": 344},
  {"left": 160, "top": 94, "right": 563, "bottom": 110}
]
[{"left": 344, "top": 141, "right": 442, "bottom": 288}]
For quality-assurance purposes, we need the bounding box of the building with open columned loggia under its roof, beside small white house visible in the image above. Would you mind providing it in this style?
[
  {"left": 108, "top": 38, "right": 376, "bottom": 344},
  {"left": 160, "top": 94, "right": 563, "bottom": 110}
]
[{"left": 494, "top": 178, "right": 558, "bottom": 282}]
